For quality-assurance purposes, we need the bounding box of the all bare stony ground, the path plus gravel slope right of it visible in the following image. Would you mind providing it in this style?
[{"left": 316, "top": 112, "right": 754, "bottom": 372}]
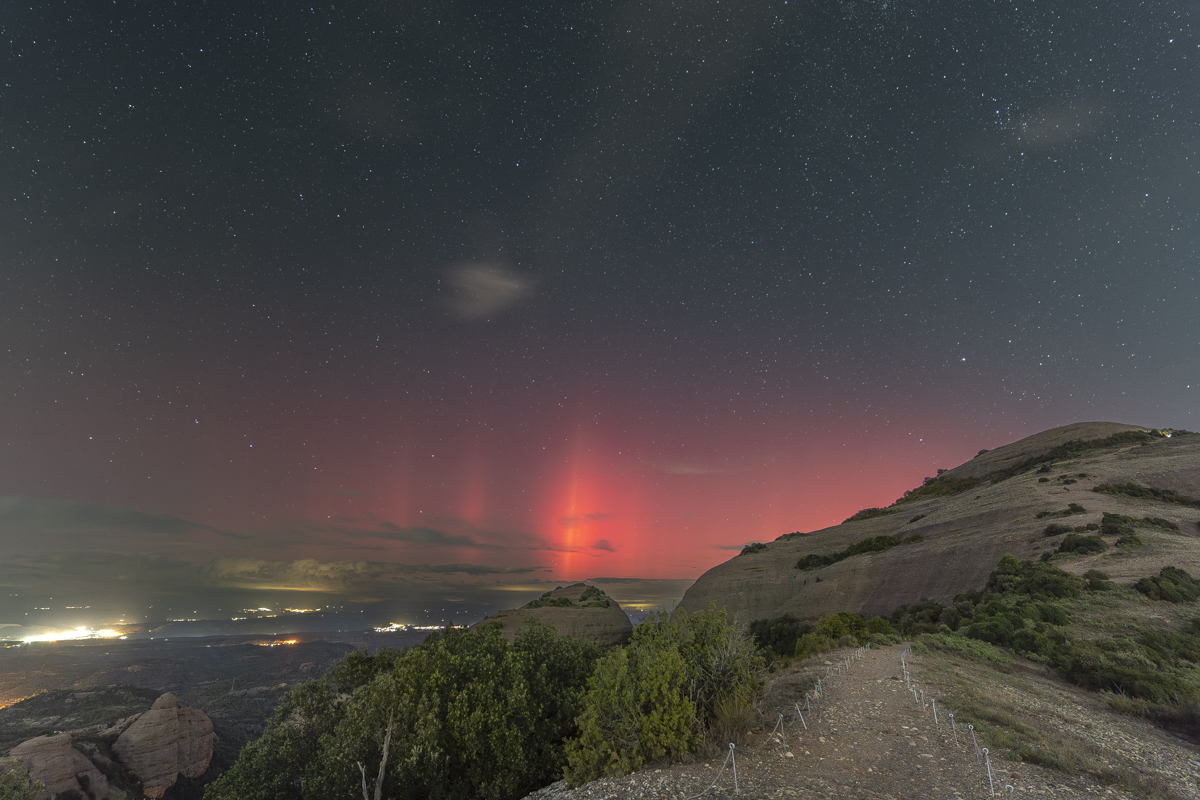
[{"left": 529, "top": 645, "right": 1200, "bottom": 800}]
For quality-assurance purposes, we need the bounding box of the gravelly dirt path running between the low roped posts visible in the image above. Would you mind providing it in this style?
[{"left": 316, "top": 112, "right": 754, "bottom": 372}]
[{"left": 530, "top": 645, "right": 1200, "bottom": 800}]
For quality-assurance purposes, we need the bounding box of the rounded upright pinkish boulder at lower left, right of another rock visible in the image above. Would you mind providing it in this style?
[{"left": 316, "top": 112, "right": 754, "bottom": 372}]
[{"left": 113, "top": 693, "right": 212, "bottom": 798}]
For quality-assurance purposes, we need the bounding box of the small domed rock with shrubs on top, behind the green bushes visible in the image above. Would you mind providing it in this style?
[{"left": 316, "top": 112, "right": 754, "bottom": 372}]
[{"left": 476, "top": 583, "right": 634, "bottom": 648}]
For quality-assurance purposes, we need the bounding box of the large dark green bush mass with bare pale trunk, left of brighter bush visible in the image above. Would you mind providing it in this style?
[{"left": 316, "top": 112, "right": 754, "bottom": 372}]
[{"left": 205, "top": 621, "right": 599, "bottom": 800}]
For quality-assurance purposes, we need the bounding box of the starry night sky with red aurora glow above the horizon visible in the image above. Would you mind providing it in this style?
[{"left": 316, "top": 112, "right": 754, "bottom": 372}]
[{"left": 0, "top": 0, "right": 1200, "bottom": 624}]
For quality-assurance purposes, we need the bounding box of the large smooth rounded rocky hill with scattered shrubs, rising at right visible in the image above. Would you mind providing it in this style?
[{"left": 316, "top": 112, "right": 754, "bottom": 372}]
[{"left": 680, "top": 422, "right": 1200, "bottom": 624}]
